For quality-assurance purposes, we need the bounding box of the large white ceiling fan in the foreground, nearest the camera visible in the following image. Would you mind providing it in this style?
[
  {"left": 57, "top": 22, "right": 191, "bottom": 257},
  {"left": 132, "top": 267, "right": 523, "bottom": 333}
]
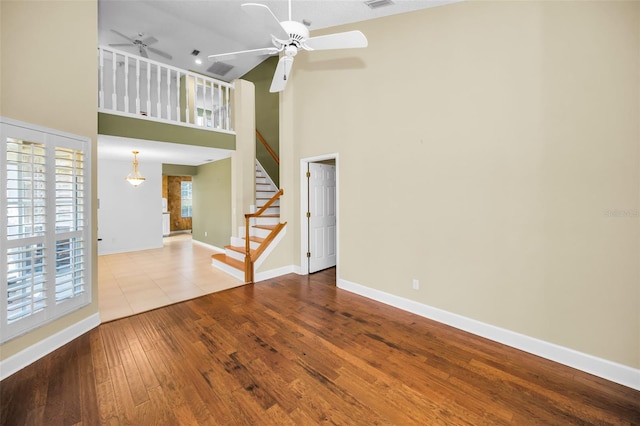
[{"left": 209, "top": 0, "right": 368, "bottom": 92}]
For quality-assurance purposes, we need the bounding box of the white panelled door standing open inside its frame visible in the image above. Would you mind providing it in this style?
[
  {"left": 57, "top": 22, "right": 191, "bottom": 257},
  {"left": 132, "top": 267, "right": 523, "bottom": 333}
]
[{"left": 307, "top": 163, "right": 336, "bottom": 273}]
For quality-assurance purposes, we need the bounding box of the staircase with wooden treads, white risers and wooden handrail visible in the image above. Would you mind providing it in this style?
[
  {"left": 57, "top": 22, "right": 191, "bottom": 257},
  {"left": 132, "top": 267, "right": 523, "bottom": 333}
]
[{"left": 211, "top": 161, "right": 286, "bottom": 282}]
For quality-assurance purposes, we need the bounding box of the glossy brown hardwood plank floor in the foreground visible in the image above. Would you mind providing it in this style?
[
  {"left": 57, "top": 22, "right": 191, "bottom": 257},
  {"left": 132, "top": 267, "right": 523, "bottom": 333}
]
[{"left": 0, "top": 270, "right": 640, "bottom": 426}]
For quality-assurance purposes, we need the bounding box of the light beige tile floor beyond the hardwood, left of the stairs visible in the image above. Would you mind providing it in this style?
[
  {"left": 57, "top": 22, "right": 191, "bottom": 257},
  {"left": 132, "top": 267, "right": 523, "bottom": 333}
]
[{"left": 98, "top": 234, "right": 244, "bottom": 322}]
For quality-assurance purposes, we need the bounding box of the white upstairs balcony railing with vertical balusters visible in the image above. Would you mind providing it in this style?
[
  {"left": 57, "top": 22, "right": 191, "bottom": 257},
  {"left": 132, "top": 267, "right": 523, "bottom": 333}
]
[{"left": 98, "top": 46, "right": 235, "bottom": 133}]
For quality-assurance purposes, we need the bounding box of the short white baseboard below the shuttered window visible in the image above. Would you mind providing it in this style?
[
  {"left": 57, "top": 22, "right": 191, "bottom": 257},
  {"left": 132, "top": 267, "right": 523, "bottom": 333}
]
[{"left": 0, "top": 313, "right": 101, "bottom": 380}]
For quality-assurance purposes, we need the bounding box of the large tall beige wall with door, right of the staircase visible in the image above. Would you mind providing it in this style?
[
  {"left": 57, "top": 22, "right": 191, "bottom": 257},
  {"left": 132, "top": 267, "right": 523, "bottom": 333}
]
[{"left": 278, "top": 1, "right": 640, "bottom": 368}]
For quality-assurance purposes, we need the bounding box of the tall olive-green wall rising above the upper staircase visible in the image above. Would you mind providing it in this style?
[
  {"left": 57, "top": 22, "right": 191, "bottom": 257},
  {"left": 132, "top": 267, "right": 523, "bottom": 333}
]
[{"left": 242, "top": 56, "right": 280, "bottom": 187}]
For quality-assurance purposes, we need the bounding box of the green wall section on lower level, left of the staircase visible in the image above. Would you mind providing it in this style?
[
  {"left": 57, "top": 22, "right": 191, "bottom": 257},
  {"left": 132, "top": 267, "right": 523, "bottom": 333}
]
[{"left": 192, "top": 158, "right": 231, "bottom": 248}]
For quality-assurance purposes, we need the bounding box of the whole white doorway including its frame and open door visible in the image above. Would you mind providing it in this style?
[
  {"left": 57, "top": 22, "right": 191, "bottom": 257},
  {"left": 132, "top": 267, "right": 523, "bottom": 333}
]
[{"left": 300, "top": 153, "right": 339, "bottom": 275}]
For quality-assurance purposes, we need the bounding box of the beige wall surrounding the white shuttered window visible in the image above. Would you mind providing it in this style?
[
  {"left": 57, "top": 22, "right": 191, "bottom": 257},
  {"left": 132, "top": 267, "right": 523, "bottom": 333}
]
[{"left": 0, "top": 0, "right": 98, "bottom": 359}]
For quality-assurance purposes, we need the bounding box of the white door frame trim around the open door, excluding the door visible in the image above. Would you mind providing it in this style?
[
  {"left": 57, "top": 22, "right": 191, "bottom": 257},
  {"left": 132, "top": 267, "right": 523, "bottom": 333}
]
[{"left": 300, "top": 152, "right": 340, "bottom": 279}]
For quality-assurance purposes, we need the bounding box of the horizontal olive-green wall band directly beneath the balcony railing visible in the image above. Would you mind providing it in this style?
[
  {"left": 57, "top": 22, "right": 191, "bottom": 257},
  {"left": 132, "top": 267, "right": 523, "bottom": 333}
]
[{"left": 98, "top": 113, "right": 236, "bottom": 150}]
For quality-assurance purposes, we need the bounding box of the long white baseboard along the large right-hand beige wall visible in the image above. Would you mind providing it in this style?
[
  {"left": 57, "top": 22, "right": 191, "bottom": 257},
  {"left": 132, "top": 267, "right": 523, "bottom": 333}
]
[{"left": 336, "top": 279, "right": 640, "bottom": 390}]
